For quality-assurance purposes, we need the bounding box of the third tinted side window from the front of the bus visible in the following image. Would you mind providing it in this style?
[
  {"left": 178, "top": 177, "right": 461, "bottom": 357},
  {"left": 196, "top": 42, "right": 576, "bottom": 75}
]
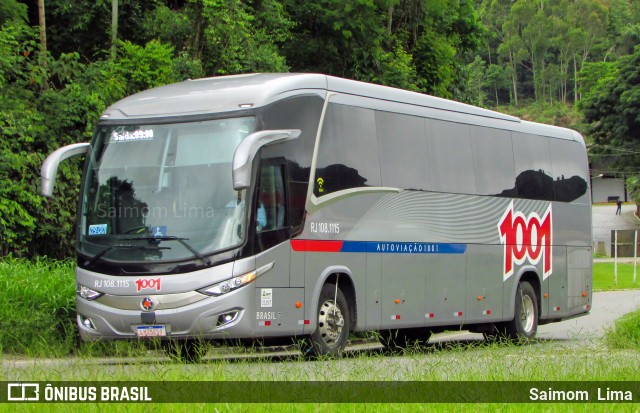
[{"left": 427, "top": 120, "right": 476, "bottom": 194}]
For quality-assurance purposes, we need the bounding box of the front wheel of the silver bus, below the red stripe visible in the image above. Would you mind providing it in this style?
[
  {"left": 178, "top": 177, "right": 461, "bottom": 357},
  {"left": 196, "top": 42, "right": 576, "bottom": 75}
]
[{"left": 302, "top": 284, "right": 351, "bottom": 358}]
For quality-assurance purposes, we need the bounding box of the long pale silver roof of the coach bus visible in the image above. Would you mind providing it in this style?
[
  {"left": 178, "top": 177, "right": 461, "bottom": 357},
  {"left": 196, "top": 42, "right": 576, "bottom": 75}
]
[{"left": 101, "top": 73, "right": 582, "bottom": 141}]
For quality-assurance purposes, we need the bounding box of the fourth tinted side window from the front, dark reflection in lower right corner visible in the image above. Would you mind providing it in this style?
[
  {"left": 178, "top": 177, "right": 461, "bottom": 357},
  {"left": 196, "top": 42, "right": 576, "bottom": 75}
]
[{"left": 472, "top": 128, "right": 516, "bottom": 197}]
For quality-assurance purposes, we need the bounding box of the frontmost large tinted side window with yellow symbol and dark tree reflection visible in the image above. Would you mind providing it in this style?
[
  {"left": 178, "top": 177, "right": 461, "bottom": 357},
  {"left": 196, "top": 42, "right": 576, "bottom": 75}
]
[{"left": 313, "top": 104, "right": 380, "bottom": 197}]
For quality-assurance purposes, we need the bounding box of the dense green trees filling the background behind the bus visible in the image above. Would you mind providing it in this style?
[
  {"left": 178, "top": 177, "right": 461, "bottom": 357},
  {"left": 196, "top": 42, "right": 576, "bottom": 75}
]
[{"left": 0, "top": 0, "right": 640, "bottom": 257}]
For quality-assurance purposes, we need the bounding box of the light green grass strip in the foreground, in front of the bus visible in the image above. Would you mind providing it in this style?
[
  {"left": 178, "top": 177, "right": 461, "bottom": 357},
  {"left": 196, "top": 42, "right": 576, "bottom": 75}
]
[{"left": 0, "top": 341, "right": 640, "bottom": 412}]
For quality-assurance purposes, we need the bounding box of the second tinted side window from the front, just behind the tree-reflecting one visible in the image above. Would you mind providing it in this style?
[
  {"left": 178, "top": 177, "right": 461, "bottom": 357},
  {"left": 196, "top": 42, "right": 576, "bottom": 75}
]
[{"left": 376, "top": 112, "right": 431, "bottom": 190}]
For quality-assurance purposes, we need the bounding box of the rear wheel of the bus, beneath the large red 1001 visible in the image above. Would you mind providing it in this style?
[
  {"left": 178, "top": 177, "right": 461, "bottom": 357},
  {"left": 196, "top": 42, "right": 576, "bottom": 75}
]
[{"left": 505, "top": 281, "right": 538, "bottom": 341}]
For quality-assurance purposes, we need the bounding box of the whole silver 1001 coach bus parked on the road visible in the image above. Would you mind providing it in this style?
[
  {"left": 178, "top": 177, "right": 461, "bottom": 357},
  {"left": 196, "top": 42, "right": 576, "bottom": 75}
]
[{"left": 42, "top": 74, "right": 592, "bottom": 356}]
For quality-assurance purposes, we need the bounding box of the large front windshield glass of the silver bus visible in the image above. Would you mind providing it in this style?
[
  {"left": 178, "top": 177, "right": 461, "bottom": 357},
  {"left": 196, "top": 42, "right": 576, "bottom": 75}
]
[{"left": 79, "top": 117, "right": 255, "bottom": 262}]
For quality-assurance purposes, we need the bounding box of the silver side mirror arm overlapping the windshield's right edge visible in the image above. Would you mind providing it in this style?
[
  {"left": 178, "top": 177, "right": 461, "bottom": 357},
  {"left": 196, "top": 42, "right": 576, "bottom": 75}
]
[{"left": 233, "top": 129, "right": 302, "bottom": 191}]
